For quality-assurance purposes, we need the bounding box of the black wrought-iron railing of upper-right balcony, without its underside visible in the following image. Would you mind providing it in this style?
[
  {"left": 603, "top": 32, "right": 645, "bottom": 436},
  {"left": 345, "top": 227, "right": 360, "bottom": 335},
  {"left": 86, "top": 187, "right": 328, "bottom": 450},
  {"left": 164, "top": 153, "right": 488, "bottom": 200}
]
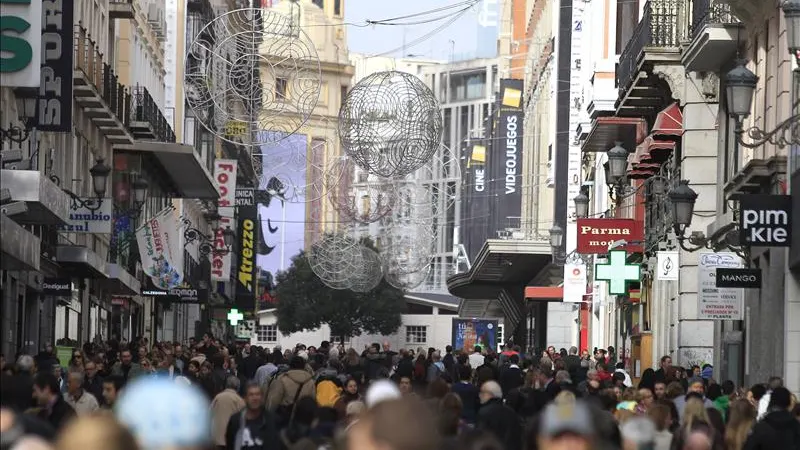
[{"left": 617, "top": 0, "right": 684, "bottom": 98}]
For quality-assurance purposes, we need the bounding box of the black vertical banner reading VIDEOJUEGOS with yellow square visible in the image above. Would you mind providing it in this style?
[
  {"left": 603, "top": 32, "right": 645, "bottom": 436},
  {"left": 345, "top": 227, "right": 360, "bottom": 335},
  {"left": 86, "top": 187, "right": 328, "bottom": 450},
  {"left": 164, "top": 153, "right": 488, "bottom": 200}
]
[{"left": 489, "top": 79, "right": 524, "bottom": 233}]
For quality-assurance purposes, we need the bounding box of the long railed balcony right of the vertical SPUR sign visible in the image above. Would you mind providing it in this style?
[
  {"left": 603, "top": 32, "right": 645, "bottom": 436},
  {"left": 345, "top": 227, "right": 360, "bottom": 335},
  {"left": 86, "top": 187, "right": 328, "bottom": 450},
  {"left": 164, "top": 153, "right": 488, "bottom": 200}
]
[{"left": 73, "top": 24, "right": 133, "bottom": 145}]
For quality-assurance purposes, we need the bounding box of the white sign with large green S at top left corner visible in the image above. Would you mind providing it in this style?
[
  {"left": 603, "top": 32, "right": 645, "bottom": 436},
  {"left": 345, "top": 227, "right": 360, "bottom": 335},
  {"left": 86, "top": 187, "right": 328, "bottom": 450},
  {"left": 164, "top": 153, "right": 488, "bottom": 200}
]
[{"left": 0, "top": 0, "right": 42, "bottom": 88}]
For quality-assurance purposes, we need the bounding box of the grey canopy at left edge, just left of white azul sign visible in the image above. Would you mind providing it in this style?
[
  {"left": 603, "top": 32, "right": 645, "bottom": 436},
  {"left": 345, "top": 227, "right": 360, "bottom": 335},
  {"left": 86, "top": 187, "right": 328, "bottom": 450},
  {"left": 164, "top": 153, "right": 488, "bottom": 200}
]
[{"left": 0, "top": 169, "right": 70, "bottom": 225}]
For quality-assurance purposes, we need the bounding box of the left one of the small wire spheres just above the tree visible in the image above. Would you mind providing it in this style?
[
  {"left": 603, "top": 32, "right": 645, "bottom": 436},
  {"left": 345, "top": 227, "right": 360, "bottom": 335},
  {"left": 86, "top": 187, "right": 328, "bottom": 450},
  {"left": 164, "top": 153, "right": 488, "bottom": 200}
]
[{"left": 308, "top": 231, "right": 362, "bottom": 289}]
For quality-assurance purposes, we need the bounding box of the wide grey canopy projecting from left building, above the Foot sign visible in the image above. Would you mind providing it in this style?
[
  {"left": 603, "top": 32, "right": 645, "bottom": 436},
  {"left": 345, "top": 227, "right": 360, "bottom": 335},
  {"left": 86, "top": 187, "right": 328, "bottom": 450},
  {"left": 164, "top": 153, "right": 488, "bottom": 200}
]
[{"left": 114, "top": 141, "right": 219, "bottom": 200}]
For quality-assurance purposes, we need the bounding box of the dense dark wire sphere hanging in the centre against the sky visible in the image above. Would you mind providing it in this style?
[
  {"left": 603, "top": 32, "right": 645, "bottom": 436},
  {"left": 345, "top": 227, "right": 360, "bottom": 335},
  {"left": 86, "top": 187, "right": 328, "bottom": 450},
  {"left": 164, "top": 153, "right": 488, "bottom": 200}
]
[{"left": 339, "top": 71, "right": 442, "bottom": 178}]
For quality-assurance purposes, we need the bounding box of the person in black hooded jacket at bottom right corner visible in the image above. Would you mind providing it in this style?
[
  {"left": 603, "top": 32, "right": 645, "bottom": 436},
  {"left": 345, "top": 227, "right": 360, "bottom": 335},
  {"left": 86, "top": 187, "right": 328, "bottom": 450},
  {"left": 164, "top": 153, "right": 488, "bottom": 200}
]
[{"left": 743, "top": 387, "right": 800, "bottom": 450}]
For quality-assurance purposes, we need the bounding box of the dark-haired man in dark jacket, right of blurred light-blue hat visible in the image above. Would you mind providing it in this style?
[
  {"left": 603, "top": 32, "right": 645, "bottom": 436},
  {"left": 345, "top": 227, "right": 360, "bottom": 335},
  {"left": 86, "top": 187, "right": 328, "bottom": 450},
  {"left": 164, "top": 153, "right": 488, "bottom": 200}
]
[{"left": 225, "top": 383, "right": 279, "bottom": 450}]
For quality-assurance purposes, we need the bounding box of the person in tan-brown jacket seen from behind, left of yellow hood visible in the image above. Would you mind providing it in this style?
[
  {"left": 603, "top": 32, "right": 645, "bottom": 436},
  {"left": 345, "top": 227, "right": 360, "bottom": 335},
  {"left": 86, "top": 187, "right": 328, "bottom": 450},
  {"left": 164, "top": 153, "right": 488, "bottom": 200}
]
[{"left": 266, "top": 356, "right": 316, "bottom": 424}]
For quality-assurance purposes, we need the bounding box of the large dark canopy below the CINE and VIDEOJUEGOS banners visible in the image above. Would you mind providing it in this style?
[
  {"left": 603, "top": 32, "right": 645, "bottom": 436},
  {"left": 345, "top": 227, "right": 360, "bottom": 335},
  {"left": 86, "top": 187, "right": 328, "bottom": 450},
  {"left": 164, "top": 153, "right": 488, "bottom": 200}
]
[{"left": 447, "top": 239, "right": 552, "bottom": 332}]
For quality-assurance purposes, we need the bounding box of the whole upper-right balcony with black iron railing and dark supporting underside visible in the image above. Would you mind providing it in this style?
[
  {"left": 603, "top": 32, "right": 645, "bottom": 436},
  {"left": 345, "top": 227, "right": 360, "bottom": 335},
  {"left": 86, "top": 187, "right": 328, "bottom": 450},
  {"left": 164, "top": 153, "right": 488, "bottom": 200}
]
[{"left": 617, "top": 0, "right": 688, "bottom": 116}]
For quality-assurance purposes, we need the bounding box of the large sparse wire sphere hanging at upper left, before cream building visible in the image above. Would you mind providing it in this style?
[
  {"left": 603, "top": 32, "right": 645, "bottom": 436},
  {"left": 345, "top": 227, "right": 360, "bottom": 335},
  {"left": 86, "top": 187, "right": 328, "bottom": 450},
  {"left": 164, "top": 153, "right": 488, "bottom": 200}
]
[{"left": 184, "top": 6, "right": 321, "bottom": 146}]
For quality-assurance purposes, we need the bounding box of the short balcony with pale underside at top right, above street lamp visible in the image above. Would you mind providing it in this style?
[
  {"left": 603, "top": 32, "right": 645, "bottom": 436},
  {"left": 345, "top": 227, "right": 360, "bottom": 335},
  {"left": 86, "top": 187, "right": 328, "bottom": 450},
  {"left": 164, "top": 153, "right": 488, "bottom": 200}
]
[{"left": 683, "top": 0, "right": 741, "bottom": 72}]
